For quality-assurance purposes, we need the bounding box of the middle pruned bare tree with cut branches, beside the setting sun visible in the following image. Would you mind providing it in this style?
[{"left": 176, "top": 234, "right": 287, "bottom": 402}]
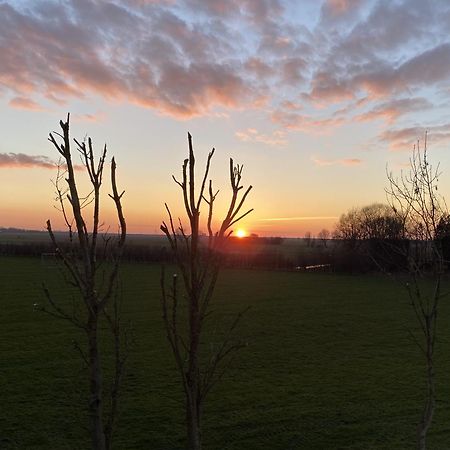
[{"left": 161, "top": 134, "right": 253, "bottom": 450}]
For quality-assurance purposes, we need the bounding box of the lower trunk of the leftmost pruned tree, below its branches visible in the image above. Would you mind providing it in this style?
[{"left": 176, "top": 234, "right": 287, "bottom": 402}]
[{"left": 87, "top": 314, "right": 106, "bottom": 450}]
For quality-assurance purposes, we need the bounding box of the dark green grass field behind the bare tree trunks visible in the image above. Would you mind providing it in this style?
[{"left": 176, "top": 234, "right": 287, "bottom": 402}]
[{"left": 0, "top": 257, "right": 450, "bottom": 450}]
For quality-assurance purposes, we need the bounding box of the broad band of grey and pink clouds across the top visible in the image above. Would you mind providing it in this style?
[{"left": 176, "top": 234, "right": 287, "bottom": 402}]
[{"left": 0, "top": 0, "right": 450, "bottom": 135}]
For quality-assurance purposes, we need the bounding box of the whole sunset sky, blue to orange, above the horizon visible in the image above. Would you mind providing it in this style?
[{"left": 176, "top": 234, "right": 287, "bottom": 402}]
[{"left": 0, "top": 0, "right": 450, "bottom": 236}]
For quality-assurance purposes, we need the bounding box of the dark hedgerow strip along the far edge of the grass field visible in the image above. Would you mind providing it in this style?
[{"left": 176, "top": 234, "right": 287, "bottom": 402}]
[{"left": 0, "top": 238, "right": 450, "bottom": 273}]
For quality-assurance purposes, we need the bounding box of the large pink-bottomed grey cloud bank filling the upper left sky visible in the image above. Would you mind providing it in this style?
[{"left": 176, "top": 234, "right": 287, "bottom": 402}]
[{"left": 0, "top": 1, "right": 262, "bottom": 118}]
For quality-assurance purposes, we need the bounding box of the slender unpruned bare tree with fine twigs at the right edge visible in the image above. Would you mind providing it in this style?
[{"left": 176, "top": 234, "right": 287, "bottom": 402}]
[{"left": 386, "top": 135, "right": 448, "bottom": 450}]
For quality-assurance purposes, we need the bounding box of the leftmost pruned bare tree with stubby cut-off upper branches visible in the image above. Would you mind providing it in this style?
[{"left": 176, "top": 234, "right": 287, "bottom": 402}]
[{"left": 41, "top": 115, "right": 128, "bottom": 450}]
